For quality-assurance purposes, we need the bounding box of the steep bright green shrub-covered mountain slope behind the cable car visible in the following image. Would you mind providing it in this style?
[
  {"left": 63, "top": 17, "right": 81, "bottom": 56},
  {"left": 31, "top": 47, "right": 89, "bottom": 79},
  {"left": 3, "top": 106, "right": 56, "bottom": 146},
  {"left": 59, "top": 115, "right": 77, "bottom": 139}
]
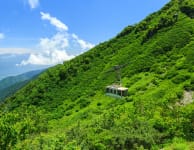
[{"left": 0, "top": 0, "right": 194, "bottom": 150}]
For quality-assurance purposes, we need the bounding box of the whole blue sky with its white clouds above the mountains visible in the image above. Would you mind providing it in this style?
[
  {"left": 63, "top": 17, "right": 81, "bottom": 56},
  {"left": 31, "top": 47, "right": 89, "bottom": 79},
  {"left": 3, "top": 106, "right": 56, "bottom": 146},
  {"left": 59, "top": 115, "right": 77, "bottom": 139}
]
[{"left": 0, "top": 0, "right": 169, "bottom": 79}]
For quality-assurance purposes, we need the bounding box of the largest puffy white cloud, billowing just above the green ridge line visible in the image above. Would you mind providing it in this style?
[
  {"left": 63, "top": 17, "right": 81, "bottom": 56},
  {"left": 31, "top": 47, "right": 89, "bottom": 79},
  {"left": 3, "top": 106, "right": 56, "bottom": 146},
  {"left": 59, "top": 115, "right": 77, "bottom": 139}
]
[{"left": 17, "top": 33, "right": 74, "bottom": 65}]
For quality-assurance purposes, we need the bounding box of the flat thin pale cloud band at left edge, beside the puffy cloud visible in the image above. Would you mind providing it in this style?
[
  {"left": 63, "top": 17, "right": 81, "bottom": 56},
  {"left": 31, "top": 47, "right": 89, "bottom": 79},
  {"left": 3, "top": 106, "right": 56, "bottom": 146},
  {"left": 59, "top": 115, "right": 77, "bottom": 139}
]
[{"left": 0, "top": 48, "right": 32, "bottom": 55}]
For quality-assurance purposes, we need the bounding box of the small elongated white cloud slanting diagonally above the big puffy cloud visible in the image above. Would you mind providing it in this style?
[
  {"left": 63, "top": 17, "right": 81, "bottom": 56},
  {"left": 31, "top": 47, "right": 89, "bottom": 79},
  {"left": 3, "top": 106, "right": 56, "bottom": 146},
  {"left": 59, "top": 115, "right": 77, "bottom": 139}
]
[{"left": 40, "top": 12, "right": 68, "bottom": 31}]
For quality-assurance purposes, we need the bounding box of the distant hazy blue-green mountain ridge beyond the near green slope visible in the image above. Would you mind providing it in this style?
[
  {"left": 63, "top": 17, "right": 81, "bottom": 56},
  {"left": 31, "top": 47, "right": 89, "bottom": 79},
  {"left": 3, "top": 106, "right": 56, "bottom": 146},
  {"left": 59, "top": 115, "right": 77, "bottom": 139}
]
[{"left": 0, "top": 70, "right": 43, "bottom": 101}]
